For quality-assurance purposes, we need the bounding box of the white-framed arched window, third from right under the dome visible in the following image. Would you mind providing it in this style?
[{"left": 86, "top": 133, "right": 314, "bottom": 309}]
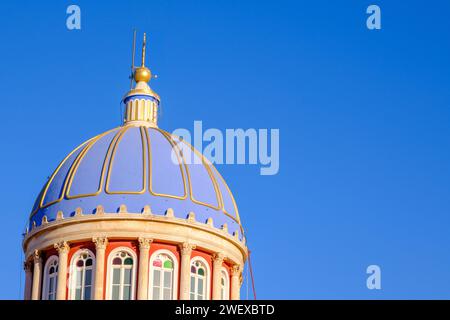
[{"left": 148, "top": 250, "right": 178, "bottom": 300}]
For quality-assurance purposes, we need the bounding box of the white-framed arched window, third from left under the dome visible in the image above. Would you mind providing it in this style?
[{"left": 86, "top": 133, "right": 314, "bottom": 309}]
[{"left": 107, "top": 247, "right": 137, "bottom": 300}]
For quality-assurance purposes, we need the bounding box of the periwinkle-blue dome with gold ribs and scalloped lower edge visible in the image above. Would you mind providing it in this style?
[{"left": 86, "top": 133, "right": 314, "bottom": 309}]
[{"left": 30, "top": 125, "right": 243, "bottom": 238}]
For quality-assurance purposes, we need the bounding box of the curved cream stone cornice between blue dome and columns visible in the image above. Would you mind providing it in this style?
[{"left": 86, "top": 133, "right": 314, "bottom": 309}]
[{"left": 23, "top": 214, "right": 247, "bottom": 265}]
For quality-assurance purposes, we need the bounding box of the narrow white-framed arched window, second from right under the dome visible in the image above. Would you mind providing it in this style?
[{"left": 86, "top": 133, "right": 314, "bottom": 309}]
[{"left": 190, "top": 257, "right": 209, "bottom": 300}]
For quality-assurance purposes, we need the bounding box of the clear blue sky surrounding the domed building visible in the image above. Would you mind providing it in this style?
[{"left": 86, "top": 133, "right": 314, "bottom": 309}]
[{"left": 0, "top": 0, "right": 450, "bottom": 299}]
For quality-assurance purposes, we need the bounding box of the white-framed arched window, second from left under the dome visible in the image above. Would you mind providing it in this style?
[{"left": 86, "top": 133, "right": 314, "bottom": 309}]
[{"left": 69, "top": 249, "right": 95, "bottom": 300}]
